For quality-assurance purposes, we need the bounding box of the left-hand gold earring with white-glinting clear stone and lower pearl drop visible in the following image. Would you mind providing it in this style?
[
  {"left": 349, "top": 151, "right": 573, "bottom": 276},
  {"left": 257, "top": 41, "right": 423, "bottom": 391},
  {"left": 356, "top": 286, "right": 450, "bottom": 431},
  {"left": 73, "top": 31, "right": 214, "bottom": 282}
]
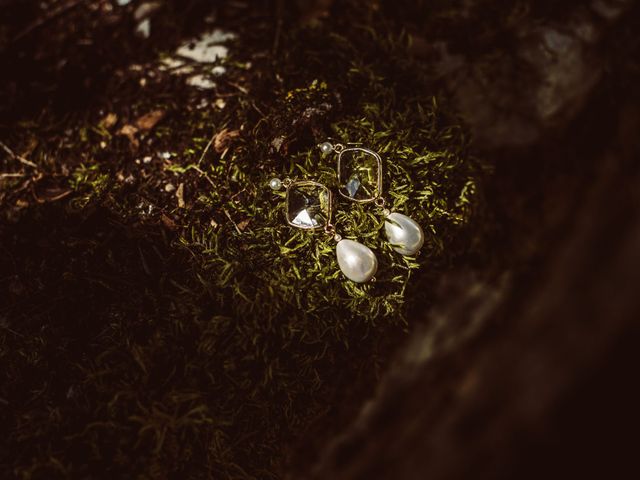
[{"left": 269, "top": 178, "right": 378, "bottom": 283}]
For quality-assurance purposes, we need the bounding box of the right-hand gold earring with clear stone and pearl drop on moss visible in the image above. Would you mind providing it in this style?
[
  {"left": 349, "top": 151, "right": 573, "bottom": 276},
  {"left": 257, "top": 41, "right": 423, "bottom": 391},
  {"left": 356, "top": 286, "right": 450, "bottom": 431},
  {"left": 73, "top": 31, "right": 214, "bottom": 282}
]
[{"left": 319, "top": 142, "right": 424, "bottom": 256}]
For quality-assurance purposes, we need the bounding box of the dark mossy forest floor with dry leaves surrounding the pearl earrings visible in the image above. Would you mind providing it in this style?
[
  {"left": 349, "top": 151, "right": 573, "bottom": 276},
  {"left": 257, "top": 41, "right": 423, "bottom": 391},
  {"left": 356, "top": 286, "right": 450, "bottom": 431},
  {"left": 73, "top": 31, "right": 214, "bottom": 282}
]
[{"left": 0, "top": 0, "right": 637, "bottom": 479}]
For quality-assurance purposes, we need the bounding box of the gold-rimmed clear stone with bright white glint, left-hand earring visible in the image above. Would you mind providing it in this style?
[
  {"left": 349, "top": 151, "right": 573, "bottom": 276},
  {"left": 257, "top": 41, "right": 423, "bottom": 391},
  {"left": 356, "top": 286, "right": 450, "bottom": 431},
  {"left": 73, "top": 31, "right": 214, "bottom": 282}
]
[{"left": 287, "top": 185, "right": 329, "bottom": 228}]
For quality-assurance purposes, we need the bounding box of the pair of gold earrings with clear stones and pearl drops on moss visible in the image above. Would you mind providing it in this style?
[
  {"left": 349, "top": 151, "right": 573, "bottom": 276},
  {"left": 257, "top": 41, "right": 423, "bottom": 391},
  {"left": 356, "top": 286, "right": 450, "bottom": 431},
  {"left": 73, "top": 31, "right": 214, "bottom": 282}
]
[{"left": 269, "top": 142, "right": 424, "bottom": 283}]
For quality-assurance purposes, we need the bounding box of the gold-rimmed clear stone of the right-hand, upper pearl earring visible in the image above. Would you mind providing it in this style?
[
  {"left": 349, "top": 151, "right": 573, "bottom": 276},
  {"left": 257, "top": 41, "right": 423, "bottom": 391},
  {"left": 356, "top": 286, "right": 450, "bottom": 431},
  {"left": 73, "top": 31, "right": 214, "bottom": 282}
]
[{"left": 338, "top": 149, "right": 380, "bottom": 201}]
